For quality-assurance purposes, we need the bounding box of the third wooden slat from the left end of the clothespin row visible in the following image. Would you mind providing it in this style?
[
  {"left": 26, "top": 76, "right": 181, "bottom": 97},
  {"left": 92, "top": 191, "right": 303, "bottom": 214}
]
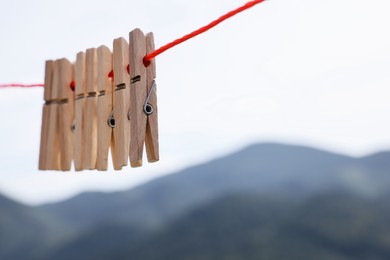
[{"left": 58, "top": 59, "right": 74, "bottom": 171}]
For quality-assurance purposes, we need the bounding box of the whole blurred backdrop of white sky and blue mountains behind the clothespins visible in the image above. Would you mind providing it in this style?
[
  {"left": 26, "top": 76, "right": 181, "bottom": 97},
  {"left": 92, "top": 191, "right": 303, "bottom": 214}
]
[{"left": 0, "top": 0, "right": 390, "bottom": 259}]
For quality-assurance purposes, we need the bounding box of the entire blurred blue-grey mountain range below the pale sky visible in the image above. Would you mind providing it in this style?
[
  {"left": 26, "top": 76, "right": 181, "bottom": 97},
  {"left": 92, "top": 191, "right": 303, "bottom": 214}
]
[{"left": 0, "top": 143, "right": 390, "bottom": 259}]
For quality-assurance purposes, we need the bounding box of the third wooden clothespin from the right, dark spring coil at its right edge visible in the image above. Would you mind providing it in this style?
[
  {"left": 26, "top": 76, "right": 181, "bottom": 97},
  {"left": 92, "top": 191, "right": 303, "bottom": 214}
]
[{"left": 96, "top": 45, "right": 122, "bottom": 171}]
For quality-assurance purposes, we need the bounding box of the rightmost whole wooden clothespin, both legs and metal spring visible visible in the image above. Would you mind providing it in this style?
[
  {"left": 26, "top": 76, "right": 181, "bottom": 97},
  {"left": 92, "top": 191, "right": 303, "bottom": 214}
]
[{"left": 129, "top": 29, "right": 159, "bottom": 167}]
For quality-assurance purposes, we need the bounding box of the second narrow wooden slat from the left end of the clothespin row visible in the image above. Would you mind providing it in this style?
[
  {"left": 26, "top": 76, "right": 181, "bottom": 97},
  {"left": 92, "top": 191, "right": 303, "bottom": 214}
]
[{"left": 45, "top": 60, "right": 61, "bottom": 170}]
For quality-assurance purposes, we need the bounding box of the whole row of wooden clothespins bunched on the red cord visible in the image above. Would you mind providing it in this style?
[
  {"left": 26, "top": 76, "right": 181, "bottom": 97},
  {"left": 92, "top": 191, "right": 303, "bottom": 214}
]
[{"left": 39, "top": 29, "right": 159, "bottom": 171}]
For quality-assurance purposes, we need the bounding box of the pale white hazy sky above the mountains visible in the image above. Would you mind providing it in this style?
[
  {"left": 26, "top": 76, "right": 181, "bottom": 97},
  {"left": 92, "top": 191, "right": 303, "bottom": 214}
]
[{"left": 0, "top": 0, "right": 390, "bottom": 204}]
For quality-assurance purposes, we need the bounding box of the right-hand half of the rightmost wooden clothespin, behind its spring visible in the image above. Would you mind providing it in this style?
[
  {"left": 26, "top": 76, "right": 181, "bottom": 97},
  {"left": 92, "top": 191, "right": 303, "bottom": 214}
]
[{"left": 145, "top": 33, "right": 160, "bottom": 163}]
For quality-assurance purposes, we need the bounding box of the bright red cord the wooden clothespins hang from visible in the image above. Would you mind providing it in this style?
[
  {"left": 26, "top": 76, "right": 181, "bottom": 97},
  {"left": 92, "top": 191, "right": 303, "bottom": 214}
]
[{"left": 0, "top": 0, "right": 265, "bottom": 88}]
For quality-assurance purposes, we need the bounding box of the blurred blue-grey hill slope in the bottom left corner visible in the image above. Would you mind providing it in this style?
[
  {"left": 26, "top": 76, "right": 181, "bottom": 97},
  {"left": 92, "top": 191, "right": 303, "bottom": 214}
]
[{"left": 0, "top": 195, "right": 74, "bottom": 259}]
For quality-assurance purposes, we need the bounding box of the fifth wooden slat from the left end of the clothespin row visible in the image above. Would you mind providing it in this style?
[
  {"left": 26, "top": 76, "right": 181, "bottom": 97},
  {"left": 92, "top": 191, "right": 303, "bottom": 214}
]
[{"left": 83, "top": 48, "right": 97, "bottom": 170}]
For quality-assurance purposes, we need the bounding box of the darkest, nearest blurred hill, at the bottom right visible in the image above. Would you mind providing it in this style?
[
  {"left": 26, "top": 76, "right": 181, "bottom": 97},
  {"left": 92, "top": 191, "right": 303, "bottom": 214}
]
[{"left": 112, "top": 194, "right": 390, "bottom": 260}]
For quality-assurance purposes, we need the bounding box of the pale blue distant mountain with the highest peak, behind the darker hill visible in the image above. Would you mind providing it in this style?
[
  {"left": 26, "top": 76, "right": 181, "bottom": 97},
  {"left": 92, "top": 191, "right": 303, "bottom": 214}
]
[{"left": 41, "top": 143, "right": 390, "bottom": 231}]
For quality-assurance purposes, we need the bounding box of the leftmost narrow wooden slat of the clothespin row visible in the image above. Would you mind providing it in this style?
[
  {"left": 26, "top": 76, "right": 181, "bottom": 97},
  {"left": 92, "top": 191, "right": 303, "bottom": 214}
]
[{"left": 38, "top": 60, "right": 54, "bottom": 170}]
